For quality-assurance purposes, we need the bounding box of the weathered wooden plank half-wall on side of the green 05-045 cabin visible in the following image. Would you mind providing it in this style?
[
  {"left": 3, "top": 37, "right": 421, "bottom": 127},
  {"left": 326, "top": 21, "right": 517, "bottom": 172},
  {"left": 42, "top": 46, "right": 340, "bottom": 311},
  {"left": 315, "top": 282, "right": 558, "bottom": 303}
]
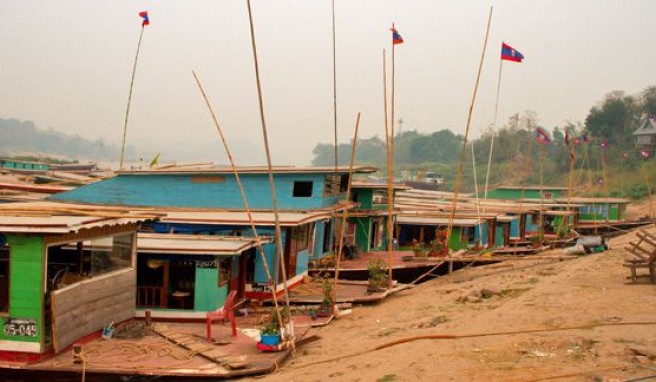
[{"left": 51, "top": 269, "right": 137, "bottom": 352}]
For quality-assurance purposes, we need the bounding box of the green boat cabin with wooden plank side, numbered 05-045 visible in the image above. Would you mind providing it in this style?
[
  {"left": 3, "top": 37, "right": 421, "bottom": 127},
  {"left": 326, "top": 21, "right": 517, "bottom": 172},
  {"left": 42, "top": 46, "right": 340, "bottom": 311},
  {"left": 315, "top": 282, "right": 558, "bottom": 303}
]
[{"left": 0, "top": 214, "right": 143, "bottom": 360}]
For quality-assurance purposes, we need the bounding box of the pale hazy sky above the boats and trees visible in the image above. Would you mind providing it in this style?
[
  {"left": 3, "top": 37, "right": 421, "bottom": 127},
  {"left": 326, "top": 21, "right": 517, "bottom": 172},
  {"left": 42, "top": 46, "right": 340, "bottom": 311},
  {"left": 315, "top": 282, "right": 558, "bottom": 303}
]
[{"left": 0, "top": 0, "right": 656, "bottom": 164}]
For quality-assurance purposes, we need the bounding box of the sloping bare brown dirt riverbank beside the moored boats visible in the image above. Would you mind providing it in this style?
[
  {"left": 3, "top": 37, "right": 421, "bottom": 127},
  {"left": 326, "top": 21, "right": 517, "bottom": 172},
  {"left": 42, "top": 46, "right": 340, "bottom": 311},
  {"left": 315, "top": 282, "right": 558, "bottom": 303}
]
[{"left": 246, "top": 227, "right": 656, "bottom": 381}]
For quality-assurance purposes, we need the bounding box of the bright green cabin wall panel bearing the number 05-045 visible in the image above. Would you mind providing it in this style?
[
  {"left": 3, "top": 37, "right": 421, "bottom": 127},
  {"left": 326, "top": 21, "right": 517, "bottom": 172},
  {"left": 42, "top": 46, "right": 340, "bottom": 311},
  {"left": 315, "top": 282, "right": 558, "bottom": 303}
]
[{"left": 0, "top": 234, "right": 45, "bottom": 348}]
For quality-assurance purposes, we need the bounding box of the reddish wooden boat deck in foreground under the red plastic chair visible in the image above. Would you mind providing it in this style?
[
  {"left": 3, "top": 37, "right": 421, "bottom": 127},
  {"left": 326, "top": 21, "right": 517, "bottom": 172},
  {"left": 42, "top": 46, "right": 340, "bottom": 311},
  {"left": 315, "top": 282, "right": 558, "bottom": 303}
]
[{"left": 14, "top": 316, "right": 310, "bottom": 379}]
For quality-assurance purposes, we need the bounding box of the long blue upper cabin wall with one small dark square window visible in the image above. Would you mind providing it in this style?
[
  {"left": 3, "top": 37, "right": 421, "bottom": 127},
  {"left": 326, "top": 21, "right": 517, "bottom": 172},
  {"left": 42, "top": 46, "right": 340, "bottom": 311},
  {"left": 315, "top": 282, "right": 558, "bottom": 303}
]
[{"left": 49, "top": 174, "right": 344, "bottom": 210}]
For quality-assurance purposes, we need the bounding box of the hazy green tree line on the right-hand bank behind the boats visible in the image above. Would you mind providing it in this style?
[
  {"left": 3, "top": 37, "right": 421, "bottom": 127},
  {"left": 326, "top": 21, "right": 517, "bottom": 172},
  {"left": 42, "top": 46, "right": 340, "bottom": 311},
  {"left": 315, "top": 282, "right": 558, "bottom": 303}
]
[{"left": 312, "top": 86, "right": 656, "bottom": 198}]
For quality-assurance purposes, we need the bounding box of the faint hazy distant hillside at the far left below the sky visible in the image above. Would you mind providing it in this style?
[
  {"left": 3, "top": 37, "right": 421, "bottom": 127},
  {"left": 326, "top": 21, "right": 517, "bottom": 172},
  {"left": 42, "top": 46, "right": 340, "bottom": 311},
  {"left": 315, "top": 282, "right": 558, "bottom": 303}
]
[{"left": 0, "top": 118, "right": 137, "bottom": 161}]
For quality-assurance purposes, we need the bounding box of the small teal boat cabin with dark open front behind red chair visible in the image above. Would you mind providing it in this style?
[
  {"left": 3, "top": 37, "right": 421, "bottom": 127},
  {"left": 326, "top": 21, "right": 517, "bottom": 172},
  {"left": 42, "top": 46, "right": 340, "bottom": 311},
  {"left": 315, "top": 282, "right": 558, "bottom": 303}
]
[{"left": 137, "top": 233, "right": 272, "bottom": 318}]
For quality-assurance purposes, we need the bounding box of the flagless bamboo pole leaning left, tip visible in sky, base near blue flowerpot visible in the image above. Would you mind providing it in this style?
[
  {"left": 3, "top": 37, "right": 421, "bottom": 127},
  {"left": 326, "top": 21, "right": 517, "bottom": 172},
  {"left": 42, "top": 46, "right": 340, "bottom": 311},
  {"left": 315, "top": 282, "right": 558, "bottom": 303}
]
[{"left": 191, "top": 71, "right": 283, "bottom": 330}]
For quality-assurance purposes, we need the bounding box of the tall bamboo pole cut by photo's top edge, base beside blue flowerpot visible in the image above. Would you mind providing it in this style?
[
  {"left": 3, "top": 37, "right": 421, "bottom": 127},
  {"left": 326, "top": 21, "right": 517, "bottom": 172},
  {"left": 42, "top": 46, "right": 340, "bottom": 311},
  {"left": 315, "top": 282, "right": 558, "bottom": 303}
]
[{"left": 246, "top": 0, "right": 296, "bottom": 346}]
